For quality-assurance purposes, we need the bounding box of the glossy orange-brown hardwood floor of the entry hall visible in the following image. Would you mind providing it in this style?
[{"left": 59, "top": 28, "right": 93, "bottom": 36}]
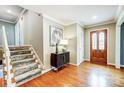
[{"left": 20, "top": 62, "right": 124, "bottom": 87}]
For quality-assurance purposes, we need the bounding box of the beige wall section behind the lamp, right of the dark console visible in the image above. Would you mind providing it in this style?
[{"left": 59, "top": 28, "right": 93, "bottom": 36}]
[{"left": 63, "top": 24, "right": 77, "bottom": 65}]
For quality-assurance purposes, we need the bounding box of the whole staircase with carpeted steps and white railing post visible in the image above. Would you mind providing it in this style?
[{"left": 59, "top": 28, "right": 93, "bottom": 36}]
[{"left": 2, "top": 26, "right": 43, "bottom": 87}]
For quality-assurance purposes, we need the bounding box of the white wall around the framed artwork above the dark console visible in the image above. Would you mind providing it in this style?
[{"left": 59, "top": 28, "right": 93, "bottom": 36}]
[{"left": 43, "top": 17, "right": 64, "bottom": 69}]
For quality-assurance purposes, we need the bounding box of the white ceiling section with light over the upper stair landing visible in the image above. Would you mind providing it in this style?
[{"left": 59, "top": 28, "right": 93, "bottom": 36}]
[{"left": 0, "top": 5, "right": 24, "bottom": 23}]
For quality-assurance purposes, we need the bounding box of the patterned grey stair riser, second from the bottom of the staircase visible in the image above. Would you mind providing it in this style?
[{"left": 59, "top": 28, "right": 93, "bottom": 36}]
[{"left": 14, "top": 64, "right": 38, "bottom": 76}]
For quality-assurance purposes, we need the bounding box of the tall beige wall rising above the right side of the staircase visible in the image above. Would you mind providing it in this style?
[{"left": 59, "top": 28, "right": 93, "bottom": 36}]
[{"left": 22, "top": 11, "right": 43, "bottom": 61}]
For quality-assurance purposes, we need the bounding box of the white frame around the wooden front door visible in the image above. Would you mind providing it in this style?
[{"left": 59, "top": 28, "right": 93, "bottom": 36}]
[{"left": 89, "top": 27, "right": 111, "bottom": 64}]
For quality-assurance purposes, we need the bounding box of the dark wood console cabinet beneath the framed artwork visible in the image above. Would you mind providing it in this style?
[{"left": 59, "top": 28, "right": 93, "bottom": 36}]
[{"left": 50, "top": 52, "right": 70, "bottom": 70}]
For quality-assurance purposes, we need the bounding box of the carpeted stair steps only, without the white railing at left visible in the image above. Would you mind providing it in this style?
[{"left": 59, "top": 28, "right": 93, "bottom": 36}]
[{"left": 3, "top": 46, "right": 42, "bottom": 86}]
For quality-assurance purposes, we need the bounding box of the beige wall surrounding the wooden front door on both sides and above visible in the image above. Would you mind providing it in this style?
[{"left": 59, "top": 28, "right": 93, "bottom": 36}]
[{"left": 84, "top": 23, "right": 116, "bottom": 64}]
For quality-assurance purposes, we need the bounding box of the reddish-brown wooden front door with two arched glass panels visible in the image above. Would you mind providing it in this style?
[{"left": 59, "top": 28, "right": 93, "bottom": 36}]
[{"left": 90, "top": 29, "right": 107, "bottom": 64}]
